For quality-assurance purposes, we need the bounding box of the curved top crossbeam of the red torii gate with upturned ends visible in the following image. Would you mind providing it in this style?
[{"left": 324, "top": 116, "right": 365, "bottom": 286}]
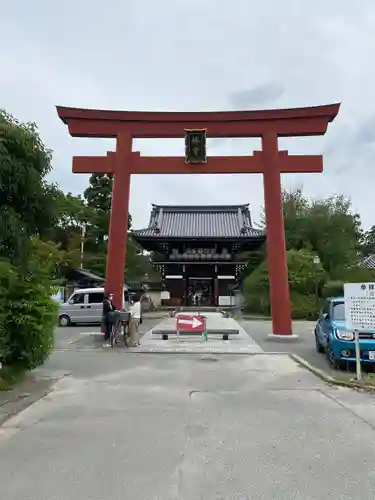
[{"left": 57, "top": 104, "right": 340, "bottom": 139}]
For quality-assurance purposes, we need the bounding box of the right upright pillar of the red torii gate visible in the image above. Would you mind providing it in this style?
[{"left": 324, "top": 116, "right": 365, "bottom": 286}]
[{"left": 262, "top": 133, "right": 292, "bottom": 335}]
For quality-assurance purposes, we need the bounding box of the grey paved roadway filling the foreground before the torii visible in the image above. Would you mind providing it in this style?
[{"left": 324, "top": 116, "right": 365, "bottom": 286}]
[{"left": 0, "top": 318, "right": 375, "bottom": 500}]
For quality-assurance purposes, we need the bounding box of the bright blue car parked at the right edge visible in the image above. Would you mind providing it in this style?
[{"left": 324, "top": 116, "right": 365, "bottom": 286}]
[{"left": 315, "top": 297, "right": 375, "bottom": 369}]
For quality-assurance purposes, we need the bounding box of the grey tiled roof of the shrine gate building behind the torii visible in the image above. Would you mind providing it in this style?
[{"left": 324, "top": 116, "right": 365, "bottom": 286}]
[{"left": 133, "top": 205, "right": 264, "bottom": 238}]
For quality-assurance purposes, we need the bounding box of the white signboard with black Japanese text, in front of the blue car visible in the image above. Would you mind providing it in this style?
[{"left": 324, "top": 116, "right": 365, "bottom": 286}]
[{"left": 344, "top": 283, "right": 375, "bottom": 330}]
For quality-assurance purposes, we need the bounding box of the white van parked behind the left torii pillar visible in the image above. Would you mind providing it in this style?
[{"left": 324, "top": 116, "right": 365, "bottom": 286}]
[{"left": 59, "top": 286, "right": 130, "bottom": 326}]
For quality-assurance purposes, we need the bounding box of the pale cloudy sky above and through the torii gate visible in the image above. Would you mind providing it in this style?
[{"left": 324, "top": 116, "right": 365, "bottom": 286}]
[{"left": 0, "top": 0, "right": 375, "bottom": 228}]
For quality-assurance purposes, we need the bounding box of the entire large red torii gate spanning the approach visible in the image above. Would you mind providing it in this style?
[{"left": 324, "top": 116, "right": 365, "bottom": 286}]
[{"left": 57, "top": 104, "right": 340, "bottom": 336}]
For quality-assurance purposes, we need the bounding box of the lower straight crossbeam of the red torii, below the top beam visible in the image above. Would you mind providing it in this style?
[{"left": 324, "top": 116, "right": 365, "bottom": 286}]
[{"left": 73, "top": 151, "right": 323, "bottom": 174}]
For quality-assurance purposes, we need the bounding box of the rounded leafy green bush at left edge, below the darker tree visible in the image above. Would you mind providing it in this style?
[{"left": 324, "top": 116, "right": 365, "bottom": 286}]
[{"left": 0, "top": 260, "right": 58, "bottom": 370}]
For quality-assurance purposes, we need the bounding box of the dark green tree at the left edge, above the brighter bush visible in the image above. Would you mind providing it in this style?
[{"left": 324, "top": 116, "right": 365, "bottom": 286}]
[{"left": 0, "top": 111, "right": 60, "bottom": 264}]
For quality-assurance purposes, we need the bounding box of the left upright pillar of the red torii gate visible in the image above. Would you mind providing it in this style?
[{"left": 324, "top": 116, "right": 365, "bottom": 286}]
[{"left": 105, "top": 134, "right": 132, "bottom": 308}]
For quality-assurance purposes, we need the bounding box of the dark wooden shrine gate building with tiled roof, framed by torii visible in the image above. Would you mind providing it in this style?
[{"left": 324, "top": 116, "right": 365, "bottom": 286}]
[{"left": 132, "top": 205, "right": 266, "bottom": 306}]
